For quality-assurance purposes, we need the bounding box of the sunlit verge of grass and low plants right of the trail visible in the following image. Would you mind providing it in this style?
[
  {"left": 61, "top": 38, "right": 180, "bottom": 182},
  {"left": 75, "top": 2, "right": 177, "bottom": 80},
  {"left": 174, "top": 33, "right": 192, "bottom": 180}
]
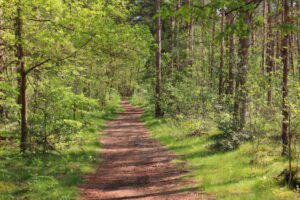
[{"left": 132, "top": 96, "right": 300, "bottom": 200}]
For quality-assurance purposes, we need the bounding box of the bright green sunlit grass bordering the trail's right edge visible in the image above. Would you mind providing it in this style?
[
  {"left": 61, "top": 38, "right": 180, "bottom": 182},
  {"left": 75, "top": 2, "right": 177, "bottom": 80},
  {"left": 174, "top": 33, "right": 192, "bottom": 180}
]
[{"left": 143, "top": 113, "right": 300, "bottom": 200}]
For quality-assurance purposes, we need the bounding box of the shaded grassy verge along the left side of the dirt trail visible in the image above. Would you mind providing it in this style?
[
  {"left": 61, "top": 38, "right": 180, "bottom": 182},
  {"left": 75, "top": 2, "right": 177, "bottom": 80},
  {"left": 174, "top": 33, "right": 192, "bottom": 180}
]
[{"left": 0, "top": 99, "right": 120, "bottom": 200}]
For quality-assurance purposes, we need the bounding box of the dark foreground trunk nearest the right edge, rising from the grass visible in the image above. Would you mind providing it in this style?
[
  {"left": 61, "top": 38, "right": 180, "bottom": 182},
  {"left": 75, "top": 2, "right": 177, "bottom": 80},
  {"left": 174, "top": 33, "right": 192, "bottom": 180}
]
[{"left": 281, "top": 0, "right": 290, "bottom": 155}]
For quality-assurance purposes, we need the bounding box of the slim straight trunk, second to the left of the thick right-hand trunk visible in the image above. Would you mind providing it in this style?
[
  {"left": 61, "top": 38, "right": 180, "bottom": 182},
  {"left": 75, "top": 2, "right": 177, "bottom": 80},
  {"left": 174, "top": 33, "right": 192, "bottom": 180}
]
[{"left": 219, "top": 8, "right": 225, "bottom": 98}]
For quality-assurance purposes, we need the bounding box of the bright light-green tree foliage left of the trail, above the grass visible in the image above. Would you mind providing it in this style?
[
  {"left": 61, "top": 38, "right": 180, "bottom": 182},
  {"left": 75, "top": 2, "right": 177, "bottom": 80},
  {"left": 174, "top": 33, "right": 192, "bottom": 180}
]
[{"left": 0, "top": 0, "right": 152, "bottom": 152}]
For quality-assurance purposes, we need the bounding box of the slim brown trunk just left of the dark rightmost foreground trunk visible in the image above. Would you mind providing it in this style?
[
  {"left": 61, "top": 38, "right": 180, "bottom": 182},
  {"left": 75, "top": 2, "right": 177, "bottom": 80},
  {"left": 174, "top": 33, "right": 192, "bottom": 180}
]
[{"left": 266, "top": 0, "right": 275, "bottom": 105}]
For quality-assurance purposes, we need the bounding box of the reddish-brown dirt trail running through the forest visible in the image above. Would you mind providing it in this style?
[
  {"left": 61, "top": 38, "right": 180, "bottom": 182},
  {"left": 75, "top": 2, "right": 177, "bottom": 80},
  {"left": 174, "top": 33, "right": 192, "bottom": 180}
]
[{"left": 80, "top": 101, "right": 214, "bottom": 200}]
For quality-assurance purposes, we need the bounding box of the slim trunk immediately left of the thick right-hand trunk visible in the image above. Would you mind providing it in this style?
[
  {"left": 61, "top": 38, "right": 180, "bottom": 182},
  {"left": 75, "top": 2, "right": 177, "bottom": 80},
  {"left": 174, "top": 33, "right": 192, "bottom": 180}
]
[{"left": 227, "top": 14, "right": 235, "bottom": 94}]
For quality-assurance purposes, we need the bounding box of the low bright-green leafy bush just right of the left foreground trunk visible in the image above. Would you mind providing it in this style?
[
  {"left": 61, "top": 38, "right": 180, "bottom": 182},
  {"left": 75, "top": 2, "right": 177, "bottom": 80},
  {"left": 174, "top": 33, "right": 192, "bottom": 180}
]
[{"left": 28, "top": 81, "right": 99, "bottom": 152}]
